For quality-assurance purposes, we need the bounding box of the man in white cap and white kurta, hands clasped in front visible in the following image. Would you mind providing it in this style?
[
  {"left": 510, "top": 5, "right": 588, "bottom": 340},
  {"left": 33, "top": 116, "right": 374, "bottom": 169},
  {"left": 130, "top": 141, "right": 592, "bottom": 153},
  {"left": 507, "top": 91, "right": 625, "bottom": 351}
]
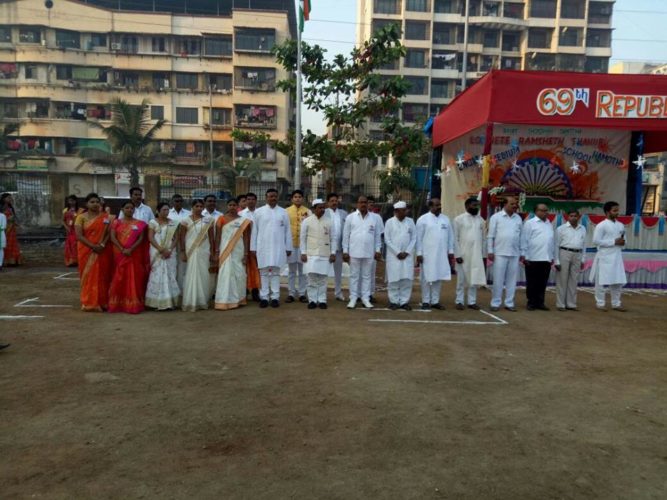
[{"left": 384, "top": 201, "right": 417, "bottom": 311}]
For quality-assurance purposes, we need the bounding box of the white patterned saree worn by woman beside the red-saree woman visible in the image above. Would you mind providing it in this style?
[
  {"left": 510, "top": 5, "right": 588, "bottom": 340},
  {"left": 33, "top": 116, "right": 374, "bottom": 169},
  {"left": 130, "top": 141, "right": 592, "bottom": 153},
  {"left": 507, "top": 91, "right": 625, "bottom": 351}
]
[{"left": 146, "top": 220, "right": 181, "bottom": 310}]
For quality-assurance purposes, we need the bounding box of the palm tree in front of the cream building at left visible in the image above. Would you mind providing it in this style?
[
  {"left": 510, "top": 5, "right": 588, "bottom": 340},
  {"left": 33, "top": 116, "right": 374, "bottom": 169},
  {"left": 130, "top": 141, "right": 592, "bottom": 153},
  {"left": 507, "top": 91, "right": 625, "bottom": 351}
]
[{"left": 78, "top": 98, "right": 171, "bottom": 186}]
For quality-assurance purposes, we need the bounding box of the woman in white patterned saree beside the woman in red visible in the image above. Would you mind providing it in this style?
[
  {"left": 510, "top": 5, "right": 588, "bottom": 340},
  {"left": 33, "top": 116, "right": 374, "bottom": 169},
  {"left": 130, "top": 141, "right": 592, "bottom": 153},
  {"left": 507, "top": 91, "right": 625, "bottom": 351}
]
[{"left": 146, "top": 203, "right": 181, "bottom": 311}]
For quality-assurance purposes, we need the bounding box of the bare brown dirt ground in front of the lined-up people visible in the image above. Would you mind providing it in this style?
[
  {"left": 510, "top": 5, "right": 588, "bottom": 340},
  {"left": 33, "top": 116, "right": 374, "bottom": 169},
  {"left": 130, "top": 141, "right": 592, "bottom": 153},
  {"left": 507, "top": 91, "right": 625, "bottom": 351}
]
[{"left": 0, "top": 267, "right": 667, "bottom": 500}]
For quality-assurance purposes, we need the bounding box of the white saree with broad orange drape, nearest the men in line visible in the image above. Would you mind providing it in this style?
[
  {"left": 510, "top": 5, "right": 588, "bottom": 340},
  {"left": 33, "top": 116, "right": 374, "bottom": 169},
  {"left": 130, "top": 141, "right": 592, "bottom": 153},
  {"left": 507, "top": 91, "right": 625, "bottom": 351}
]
[{"left": 215, "top": 217, "right": 250, "bottom": 311}]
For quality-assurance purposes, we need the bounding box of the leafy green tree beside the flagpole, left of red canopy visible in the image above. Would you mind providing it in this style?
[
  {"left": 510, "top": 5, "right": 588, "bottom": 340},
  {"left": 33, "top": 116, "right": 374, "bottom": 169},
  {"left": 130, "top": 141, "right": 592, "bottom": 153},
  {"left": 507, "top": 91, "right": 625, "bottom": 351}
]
[{"left": 232, "top": 24, "right": 420, "bottom": 194}]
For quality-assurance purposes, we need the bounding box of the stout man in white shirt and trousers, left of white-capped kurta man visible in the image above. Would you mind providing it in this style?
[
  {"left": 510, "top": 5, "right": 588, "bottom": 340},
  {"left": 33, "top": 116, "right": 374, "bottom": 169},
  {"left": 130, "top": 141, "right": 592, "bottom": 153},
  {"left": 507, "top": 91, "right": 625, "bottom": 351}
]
[{"left": 343, "top": 196, "right": 382, "bottom": 309}]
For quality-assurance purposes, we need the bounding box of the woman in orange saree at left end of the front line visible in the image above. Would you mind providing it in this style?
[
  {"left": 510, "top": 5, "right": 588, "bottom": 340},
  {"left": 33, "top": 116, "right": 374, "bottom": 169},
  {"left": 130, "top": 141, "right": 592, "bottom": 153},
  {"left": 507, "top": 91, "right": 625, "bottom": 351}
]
[{"left": 74, "top": 193, "right": 111, "bottom": 311}]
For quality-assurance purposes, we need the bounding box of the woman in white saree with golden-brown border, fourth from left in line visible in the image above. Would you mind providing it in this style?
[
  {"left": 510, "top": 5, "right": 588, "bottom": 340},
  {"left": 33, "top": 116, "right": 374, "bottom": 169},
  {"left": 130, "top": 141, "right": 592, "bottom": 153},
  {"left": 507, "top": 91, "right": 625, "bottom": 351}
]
[{"left": 179, "top": 199, "right": 216, "bottom": 311}]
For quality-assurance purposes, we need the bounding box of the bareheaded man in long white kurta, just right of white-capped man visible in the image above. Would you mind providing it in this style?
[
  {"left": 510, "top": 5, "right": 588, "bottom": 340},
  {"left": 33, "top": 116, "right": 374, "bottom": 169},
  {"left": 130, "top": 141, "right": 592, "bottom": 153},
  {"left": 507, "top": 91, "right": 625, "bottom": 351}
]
[{"left": 416, "top": 198, "right": 455, "bottom": 310}]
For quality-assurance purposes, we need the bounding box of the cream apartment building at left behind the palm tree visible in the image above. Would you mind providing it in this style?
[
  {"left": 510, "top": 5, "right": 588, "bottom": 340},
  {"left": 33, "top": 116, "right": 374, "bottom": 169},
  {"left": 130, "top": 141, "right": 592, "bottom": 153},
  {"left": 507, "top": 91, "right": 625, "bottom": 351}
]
[{"left": 0, "top": 0, "right": 296, "bottom": 194}]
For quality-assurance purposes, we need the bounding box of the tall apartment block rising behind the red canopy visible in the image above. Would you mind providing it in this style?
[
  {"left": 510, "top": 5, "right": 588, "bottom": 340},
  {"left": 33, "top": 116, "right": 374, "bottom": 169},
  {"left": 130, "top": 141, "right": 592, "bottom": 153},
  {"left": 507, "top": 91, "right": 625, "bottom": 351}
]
[{"left": 357, "top": 0, "right": 614, "bottom": 191}]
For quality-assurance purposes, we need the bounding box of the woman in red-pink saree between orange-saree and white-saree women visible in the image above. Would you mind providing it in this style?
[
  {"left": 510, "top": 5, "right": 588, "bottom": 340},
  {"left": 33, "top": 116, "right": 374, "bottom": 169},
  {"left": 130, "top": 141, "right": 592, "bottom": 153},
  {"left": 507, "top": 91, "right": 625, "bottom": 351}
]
[{"left": 109, "top": 200, "right": 148, "bottom": 314}]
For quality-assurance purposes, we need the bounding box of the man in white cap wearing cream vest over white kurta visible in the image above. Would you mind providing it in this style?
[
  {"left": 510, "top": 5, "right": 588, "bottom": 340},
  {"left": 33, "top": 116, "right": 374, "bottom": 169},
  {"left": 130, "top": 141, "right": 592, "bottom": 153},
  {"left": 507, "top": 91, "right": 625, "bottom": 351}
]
[{"left": 299, "top": 198, "right": 336, "bottom": 309}]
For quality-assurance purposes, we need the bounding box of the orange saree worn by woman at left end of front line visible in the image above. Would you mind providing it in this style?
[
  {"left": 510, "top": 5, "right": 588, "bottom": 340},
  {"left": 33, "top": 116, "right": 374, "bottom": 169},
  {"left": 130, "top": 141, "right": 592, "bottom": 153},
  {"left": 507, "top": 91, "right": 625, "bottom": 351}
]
[{"left": 77, "top": 213, "right": 112, "bottom": 311}]
